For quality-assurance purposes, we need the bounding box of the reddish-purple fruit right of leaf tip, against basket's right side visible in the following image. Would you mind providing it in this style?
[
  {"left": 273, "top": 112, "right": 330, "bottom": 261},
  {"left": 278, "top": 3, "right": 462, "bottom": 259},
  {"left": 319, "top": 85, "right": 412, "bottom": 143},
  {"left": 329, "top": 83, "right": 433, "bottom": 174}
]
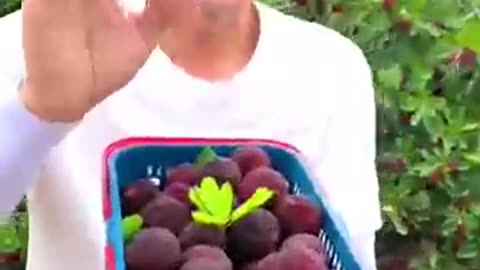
[{"left": 273, "top": 195, "right": 321, "bottom": 237}]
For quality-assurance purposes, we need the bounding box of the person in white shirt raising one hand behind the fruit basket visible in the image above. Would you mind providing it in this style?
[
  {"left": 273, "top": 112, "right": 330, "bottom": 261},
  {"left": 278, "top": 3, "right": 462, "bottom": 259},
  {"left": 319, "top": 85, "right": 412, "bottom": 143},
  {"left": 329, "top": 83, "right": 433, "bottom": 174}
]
[{"left": 0, "top": 0, "right": 381, "bottom": 270}]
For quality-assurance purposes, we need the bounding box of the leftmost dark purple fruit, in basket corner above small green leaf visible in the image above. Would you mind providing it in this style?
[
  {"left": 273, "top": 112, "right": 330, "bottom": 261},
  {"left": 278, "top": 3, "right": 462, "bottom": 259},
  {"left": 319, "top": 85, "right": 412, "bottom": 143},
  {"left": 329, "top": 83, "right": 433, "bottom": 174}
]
[{"left": 122, "top": 179, "right": 160, "bottom": 215}]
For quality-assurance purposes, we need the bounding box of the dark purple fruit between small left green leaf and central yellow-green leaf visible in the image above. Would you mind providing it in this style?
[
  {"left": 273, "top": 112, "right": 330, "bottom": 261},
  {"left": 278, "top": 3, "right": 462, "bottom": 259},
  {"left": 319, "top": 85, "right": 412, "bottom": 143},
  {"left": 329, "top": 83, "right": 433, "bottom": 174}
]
[{"left": 140, "top": 194, "right": 190, "bottom": 235}]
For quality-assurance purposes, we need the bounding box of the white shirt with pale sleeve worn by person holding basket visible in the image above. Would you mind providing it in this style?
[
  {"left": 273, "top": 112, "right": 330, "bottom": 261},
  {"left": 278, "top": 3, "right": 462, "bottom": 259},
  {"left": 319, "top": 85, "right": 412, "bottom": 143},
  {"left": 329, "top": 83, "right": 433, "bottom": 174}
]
[{"left": 0, "top": 1, "right": 381, "bottom": 270}]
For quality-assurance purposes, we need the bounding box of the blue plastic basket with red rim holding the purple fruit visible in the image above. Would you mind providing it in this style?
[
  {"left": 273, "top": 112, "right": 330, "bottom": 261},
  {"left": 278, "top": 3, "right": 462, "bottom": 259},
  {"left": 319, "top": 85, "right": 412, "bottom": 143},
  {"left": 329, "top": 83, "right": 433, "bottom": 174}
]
[{"left": 104, "top": 138, "right": 361, "bottom": 270}]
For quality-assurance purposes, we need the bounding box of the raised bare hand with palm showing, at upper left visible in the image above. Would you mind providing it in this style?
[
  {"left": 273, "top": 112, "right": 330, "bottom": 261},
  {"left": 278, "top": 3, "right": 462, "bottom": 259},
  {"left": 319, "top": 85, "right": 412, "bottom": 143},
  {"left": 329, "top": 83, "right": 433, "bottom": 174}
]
[{"left": 21, "top": 0, "right": 186, "bottom": 122}]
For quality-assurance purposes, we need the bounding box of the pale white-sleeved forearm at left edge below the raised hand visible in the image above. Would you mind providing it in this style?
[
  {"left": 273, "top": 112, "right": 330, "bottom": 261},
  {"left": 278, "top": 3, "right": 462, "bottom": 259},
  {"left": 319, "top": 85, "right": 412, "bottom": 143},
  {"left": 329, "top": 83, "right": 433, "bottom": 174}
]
[{"left": 0, "top": 92, "right": 72, "bottom": 217}]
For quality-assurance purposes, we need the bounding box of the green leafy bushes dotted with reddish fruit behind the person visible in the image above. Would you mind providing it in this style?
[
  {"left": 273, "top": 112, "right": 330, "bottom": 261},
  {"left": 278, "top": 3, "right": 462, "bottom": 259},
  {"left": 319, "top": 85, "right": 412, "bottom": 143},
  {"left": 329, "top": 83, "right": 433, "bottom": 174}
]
[{"left": 0, "top": 0, "right": 480, "bottom": 270}]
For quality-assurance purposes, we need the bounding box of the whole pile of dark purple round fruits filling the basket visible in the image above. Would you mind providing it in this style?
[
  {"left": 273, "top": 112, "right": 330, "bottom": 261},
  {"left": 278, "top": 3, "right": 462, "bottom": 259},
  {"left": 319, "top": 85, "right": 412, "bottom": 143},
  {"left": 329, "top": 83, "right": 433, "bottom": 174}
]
[{"left": 122, "top": 146, "right": 327, "bottom": 270}]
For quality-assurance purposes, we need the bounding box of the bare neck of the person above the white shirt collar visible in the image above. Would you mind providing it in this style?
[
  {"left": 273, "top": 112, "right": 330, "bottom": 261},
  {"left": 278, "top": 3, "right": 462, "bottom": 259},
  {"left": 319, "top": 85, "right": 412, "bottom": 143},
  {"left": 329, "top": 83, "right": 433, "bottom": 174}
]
[{"left": 160, "top": 5, "right": 259, "bottom": 80}]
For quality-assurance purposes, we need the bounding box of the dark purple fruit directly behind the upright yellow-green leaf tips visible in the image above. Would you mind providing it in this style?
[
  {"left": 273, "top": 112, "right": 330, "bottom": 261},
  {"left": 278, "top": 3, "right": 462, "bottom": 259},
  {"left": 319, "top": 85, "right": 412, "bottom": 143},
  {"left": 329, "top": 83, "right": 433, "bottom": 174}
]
[{"left": 202, "top": 158, "right": 242, "bottom": 188}]
